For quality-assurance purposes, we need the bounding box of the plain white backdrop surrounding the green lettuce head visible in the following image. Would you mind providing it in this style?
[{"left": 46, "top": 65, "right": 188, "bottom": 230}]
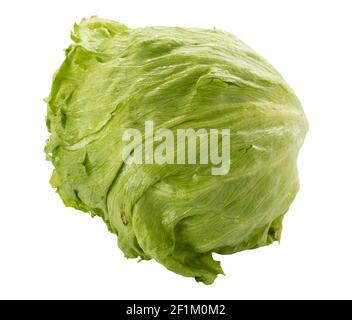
[{"left": 0, "top": 0, "right": 352, "bottom": 299}]
